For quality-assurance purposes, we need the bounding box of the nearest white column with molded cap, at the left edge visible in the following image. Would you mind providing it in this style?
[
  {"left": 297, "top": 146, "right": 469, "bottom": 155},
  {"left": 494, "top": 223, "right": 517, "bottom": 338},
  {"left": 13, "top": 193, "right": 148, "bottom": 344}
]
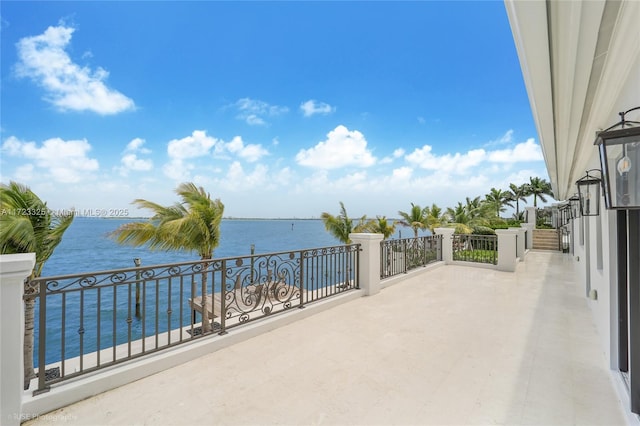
[{"left": 0, "top": 253, "right": 36, "bottom": 426}]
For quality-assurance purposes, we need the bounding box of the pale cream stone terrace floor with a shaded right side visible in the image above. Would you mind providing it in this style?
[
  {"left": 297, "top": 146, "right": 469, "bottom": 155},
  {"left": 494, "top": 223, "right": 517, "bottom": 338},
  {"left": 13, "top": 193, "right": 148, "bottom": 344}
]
[{"left": 26, "top": 251, "right": 630, "bottom": 425}]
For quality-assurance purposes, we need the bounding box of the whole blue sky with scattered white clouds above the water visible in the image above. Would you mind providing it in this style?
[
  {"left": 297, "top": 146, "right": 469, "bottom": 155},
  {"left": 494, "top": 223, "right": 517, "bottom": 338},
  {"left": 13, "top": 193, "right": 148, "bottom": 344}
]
[{"left": 0, "top": 1, "right": 548, "bottom": 218}]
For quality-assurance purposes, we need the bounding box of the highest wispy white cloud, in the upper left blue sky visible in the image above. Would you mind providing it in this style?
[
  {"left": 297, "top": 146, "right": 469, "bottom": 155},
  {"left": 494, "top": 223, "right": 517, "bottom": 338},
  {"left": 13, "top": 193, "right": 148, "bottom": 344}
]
[{"left": 16, "top": 25, "right": 135, "bottom": 115}]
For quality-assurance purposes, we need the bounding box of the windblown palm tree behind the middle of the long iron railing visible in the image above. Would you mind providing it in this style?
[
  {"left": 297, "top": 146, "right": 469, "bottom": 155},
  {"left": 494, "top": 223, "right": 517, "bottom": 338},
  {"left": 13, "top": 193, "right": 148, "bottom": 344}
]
[{"left": 110, "top": 182, "right": 224, "bottom": 333}]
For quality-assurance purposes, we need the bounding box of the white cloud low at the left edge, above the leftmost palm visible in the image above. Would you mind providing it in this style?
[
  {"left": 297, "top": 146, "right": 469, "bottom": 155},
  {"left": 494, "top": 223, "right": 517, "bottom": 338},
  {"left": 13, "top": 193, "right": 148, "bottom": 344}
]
[{"left": 2, "top": 136, "right": 99, "bottom": 183}]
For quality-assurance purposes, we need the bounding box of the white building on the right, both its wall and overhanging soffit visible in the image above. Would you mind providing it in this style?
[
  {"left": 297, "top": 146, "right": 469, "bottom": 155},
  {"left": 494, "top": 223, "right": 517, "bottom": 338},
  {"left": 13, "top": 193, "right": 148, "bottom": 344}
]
[{"left": 505, "top": 0, "right": 640, "bottom": 415}]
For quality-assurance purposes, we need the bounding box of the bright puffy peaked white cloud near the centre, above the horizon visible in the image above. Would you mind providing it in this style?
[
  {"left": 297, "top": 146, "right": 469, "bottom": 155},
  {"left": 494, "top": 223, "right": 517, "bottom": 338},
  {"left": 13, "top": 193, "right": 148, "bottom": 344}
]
[{"left": 296, "top": 125, "right": 376, "bottom": 169}]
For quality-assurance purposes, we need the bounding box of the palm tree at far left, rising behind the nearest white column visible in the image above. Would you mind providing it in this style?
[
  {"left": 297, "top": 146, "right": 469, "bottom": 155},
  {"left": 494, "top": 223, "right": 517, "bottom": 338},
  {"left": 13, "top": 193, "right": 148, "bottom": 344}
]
[{"left": 0, "top": 182, "right": 74, "bottom": 389}]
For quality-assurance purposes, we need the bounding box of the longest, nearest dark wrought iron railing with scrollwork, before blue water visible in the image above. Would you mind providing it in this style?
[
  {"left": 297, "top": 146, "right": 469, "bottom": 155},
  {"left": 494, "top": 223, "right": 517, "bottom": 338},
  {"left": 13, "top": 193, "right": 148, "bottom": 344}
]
[{"left": 25, "top": 244, "right": 360, "bottom": 393}]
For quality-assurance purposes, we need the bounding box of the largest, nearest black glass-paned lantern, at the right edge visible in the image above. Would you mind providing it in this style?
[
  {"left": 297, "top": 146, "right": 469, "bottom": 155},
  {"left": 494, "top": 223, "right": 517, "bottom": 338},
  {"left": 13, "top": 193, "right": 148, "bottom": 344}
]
[{"left": 595, "top": 107, "right": 640, "bottom": 210}]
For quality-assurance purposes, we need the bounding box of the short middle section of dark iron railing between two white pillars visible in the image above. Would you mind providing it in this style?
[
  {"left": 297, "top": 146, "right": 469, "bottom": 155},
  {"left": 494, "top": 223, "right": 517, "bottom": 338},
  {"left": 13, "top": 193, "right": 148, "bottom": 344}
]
[{"left": 380, "top": 235, "right": 442, "bottom": 279}]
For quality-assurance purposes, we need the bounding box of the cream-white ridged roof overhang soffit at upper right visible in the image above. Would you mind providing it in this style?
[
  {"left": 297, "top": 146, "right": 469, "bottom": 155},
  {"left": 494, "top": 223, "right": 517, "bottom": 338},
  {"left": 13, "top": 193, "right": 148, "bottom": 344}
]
[{"left": 505, "top": 0, "right": 640, "bottom": 200}]
